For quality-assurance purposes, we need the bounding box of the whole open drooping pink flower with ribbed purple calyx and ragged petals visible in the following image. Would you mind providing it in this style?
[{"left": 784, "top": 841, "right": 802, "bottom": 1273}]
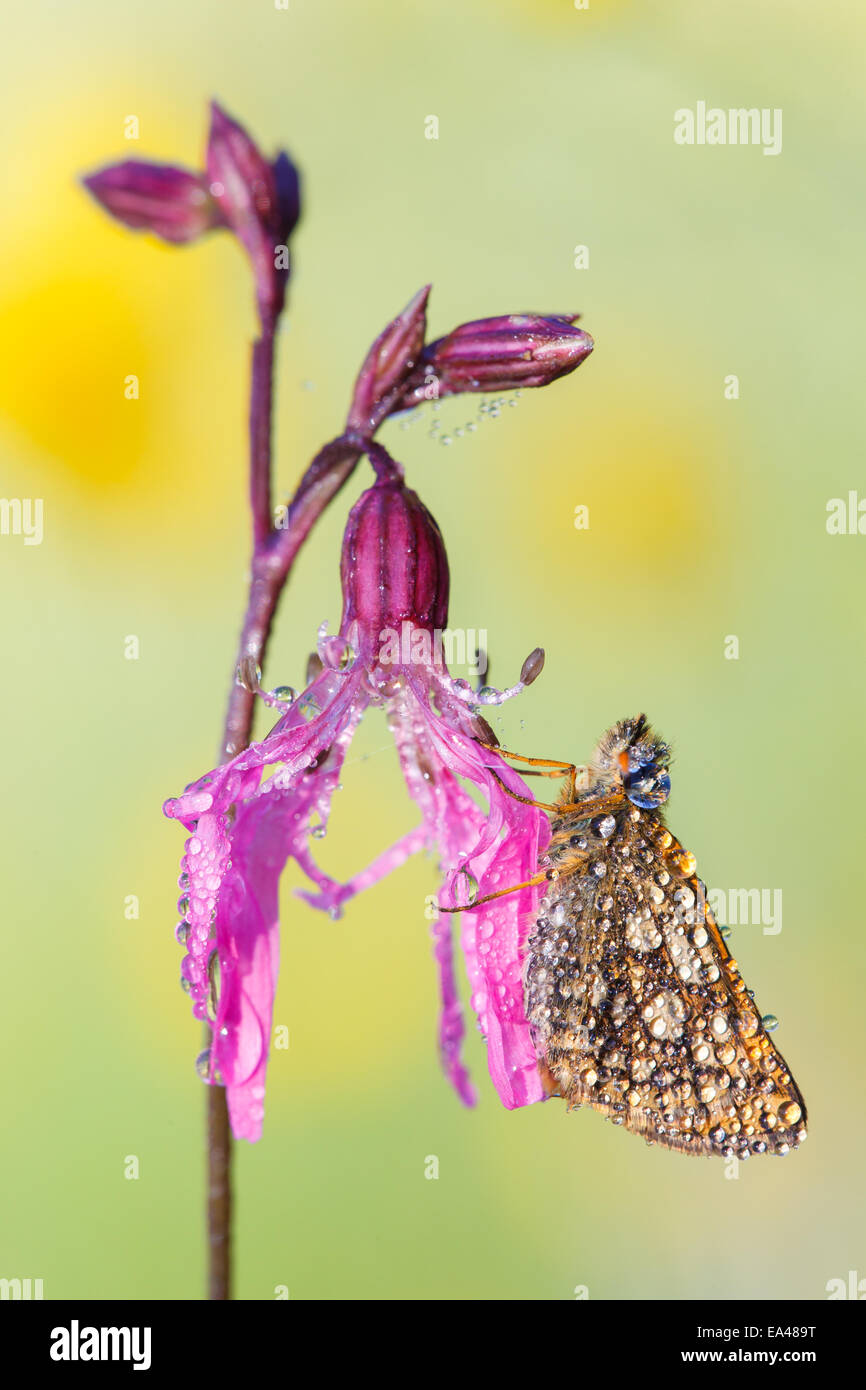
[{"left": 164, "top": 443, "right": 549, "bottom": 1141}]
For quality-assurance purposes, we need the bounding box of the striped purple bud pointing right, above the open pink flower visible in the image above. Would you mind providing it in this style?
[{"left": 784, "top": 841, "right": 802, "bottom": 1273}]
[{"left": 395, "top": 314, "right": 594, "bottom": 410}]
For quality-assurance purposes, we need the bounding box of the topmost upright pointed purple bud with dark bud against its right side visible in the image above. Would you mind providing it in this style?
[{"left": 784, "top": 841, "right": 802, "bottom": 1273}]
[{"left": 207, "top": 101, "right": 300, "bottom": 317}]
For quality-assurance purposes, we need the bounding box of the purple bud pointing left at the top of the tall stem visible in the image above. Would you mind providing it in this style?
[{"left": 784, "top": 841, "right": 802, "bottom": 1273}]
[{"left": 83, "top": 160, "right": 225, "bottom": 243}]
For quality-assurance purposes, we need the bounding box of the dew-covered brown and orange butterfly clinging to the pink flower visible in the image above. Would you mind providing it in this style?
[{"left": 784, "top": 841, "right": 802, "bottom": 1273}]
[{"left": 496, "top": 714, "right": 806, "bottom": 1158}]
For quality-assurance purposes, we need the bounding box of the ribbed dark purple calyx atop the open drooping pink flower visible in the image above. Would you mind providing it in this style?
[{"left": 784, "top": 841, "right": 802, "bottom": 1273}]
[{"left": 341, "top": 470, "right": 449, "bottom": 662}]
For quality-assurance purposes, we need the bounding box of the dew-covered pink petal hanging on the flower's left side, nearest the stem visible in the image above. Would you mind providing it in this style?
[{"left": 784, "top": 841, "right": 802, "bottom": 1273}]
[{"left": 164, "top": 670, "right": 366, "bottom": 1140}]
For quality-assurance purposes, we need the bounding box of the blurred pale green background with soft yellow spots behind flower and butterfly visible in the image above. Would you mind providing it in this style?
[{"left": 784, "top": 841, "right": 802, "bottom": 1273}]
[{"left": 0, "top": 0, "right": 866, "bottom": 1300}]
